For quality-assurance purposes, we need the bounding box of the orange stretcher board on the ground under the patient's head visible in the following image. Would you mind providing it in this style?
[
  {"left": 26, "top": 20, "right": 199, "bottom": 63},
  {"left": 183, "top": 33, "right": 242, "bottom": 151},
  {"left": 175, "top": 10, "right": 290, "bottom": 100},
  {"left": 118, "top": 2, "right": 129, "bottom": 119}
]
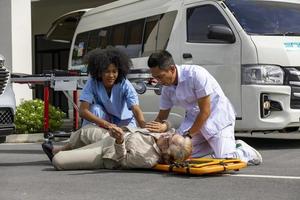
[{"left": 153, "top": 158, "right": 247, "bottom": 175}]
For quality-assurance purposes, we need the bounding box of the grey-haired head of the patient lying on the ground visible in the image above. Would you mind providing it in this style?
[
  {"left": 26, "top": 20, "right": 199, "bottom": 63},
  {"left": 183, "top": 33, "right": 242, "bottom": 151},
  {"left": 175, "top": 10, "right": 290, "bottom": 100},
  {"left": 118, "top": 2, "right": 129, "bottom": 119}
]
[{"left": 157, "top": 132, "right": 192, "bottom": 164}]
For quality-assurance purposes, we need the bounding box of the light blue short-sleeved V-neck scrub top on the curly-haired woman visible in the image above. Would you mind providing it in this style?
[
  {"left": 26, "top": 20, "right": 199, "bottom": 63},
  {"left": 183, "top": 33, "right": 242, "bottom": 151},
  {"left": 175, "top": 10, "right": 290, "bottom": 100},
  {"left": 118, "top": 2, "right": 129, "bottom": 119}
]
[{"left": 79, "top": 78, "right": 139, "bottom": 120}]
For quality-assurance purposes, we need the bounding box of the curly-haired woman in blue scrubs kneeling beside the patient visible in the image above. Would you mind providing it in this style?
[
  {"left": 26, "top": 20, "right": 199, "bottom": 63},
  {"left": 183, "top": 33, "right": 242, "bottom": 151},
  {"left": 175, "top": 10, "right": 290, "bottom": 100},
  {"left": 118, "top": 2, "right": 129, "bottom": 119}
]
[{"left": 79, "top": 47, "right": 145, "bottom": 129}]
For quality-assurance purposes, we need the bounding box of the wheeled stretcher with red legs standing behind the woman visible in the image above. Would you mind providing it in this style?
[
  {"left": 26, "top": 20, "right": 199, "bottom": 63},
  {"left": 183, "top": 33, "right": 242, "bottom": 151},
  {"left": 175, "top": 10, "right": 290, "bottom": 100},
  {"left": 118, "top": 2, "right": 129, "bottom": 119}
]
[{"left": 11, "top": 69, "right": 161, "bottom": 138}]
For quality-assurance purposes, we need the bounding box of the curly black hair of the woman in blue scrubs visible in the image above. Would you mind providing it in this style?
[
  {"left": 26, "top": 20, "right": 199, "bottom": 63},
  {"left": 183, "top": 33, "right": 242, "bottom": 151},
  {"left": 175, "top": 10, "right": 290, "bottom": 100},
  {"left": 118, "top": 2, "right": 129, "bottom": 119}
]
[{"left": 85, "top": 47, "right": 132, "bottom": 83}]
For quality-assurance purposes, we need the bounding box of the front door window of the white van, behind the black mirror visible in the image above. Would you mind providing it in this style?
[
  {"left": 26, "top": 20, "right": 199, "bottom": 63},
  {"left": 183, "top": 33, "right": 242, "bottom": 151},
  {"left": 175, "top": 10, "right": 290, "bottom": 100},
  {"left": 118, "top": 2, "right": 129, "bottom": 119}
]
[{"left": 186, "top": 5, "right": 229, "bottom": 43}]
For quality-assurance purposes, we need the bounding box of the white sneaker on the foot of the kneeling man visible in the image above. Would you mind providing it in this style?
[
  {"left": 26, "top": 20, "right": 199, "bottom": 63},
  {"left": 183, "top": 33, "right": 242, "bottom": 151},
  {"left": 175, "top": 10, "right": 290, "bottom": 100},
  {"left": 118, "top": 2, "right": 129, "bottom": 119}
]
[{"left": 235, "top": 140, "right": 262, "bottom": 165}]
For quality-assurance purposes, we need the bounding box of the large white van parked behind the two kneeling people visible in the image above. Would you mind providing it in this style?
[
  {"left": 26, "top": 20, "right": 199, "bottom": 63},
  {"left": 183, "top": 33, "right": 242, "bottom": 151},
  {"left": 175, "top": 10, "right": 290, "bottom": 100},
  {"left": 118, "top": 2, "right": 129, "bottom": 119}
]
[{"left": 47, "top": 0, "right": 300, "bottom": 132}]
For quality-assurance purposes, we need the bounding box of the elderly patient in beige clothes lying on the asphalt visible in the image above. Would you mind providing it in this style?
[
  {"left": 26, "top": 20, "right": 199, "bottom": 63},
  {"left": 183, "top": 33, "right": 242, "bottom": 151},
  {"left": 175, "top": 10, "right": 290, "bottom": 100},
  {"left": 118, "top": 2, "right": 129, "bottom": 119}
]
[{"left": 42, "top": 125, "right": 192, "bottom": 170}]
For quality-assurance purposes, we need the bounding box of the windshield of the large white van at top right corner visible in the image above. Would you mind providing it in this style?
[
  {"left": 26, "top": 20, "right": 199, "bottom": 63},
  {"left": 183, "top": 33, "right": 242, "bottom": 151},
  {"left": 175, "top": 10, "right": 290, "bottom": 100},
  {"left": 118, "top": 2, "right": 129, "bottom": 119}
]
[{"left": 225, "top": 0, "right": 300, "bottom": 36}]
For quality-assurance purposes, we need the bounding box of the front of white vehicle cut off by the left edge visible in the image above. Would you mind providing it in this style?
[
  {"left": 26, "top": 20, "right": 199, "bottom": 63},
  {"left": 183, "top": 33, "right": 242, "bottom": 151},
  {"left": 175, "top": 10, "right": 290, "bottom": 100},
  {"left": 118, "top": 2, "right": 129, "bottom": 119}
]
[{"left": 0, "top": 54, "right": 16, "bottom": 142}]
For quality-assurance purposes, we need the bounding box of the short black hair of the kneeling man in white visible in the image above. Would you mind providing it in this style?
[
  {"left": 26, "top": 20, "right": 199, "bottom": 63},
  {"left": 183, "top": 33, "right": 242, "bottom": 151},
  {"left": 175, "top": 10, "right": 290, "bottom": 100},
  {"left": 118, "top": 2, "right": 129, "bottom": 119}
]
[{"left": 148, "top": 50, "right": 175, "bottom": 69}]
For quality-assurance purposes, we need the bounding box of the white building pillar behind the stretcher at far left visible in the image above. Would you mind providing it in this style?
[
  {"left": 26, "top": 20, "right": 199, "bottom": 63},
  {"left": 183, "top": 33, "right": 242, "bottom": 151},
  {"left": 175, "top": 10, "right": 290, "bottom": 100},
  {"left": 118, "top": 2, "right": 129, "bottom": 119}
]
[{"left": 0, "top": 0, "right": 32, "bottom": 105}]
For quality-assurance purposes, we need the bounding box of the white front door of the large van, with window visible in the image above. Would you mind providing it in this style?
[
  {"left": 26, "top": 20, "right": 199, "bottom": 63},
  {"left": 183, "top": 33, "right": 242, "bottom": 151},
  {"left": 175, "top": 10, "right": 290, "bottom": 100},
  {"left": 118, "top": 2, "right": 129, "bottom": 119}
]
[{"left": 181, "top": 1, "right": 241, "bottom": 117}]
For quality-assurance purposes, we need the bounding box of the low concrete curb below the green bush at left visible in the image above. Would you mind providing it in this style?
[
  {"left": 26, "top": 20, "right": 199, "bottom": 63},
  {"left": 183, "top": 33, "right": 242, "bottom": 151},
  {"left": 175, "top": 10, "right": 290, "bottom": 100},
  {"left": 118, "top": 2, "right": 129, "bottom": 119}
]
[{"left": 5, "top": 133, "right": 44, "bottom": 143}]
